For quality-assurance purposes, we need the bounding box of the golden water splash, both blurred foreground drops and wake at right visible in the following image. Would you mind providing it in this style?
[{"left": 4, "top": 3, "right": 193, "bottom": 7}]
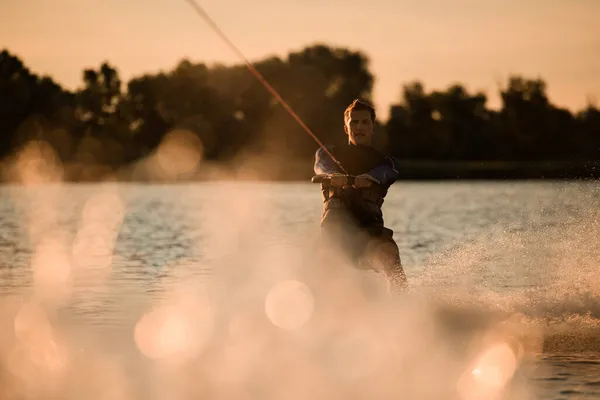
[{"left": 0, "top": 137, "right": 600, "bottom": 400}]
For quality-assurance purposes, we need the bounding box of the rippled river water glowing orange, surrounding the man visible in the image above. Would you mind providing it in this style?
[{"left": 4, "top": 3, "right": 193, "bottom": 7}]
[{"left": 0, "top": 181, "right": 600, "bottom": 400}]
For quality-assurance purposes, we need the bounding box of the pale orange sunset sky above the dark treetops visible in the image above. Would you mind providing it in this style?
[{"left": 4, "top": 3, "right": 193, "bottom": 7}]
[{"left": 0, "top": 0, "right": 600, "bottom": 116}]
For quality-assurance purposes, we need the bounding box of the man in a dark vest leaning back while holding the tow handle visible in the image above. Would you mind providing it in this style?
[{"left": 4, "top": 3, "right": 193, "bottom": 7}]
[{"left": 314, "top": 100, "right": 407, "bottom": 292}]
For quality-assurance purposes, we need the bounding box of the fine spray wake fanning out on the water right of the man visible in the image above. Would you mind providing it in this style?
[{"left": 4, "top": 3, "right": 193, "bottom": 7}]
[{"left": 410, "top": 206, "right": 600, "bottom": 357}]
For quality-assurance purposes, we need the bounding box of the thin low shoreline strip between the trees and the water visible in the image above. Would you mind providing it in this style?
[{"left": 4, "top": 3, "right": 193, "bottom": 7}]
[{"left": 0, "top": 158, "right": 600, "bottom": 184}]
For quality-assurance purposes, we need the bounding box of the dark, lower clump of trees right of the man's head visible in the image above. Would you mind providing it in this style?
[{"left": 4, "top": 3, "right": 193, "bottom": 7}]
[{"left": 386, "top": 76, "right": 599, "bottom": 166}]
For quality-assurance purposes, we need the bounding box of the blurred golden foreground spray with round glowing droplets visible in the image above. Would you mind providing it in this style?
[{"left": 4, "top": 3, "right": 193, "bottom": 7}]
[{"left": 0, "top": 131, "right": 598, "bottom": 400}]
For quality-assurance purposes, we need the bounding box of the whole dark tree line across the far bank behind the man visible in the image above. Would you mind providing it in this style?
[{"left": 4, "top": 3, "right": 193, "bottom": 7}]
[{"left": 0, "top": 44, "right": 600, "bottom": 178}]
